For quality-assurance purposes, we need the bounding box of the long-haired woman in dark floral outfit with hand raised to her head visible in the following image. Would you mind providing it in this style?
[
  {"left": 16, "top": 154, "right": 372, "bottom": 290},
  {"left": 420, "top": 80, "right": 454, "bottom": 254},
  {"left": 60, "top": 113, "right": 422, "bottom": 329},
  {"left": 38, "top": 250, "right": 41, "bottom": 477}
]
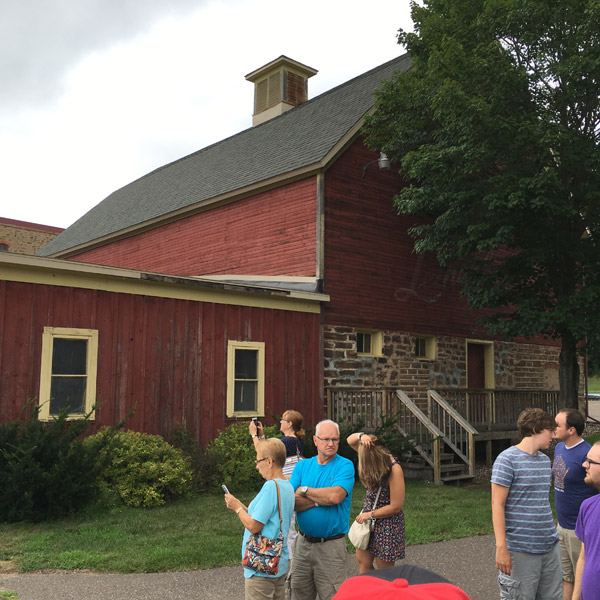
[{"left": 348, "top": 432, "right": 405, "bottom": 573}]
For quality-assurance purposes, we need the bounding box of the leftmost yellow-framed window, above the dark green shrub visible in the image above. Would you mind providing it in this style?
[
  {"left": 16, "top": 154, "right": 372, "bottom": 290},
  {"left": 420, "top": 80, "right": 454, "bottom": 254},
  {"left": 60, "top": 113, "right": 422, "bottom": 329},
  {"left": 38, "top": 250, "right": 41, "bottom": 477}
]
[{"left": 39, "top": 327, "right": 98, "bottom": 421}]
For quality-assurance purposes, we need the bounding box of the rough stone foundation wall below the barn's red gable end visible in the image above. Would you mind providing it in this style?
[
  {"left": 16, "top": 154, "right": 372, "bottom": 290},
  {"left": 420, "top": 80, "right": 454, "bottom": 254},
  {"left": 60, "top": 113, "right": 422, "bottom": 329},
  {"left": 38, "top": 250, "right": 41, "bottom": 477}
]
[{"left": 324, "top": 325, "right": 560, "bottom": 406}]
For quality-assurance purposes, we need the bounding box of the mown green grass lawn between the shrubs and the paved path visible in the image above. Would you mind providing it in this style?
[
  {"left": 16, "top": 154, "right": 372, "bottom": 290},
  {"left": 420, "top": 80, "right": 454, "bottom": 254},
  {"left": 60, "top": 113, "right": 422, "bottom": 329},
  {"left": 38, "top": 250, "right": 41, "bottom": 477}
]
[{"left": 0, "top": 481, "right": 492, "bottom": 573}]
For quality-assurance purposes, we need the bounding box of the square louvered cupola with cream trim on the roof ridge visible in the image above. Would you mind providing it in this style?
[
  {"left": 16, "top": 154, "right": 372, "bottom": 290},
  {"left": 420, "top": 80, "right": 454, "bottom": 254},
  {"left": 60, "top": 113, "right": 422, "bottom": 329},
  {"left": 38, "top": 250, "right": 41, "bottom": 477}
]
[{"left": 246, "top": 55, "right": 318, "bottom": 125}]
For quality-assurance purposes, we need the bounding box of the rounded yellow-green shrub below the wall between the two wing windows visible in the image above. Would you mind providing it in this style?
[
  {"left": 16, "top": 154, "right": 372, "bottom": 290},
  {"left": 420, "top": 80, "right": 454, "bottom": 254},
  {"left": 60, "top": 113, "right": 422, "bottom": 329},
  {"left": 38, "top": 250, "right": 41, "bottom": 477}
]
[{"left": 85, "top": 428, "right": 192, "bottom": 508}]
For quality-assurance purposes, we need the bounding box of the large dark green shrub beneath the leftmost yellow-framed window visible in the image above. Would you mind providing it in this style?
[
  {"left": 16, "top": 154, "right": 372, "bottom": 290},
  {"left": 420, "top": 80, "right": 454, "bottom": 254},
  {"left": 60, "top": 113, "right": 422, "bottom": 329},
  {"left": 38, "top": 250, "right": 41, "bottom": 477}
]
[{"left": 0, "top": 400, "right": 97, "bottom": 522}]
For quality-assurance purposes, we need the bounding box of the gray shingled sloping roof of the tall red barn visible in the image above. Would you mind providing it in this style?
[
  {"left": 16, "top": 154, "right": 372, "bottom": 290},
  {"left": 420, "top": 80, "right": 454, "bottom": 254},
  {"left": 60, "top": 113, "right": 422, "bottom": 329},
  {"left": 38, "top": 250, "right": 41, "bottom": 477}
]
[{"left": 38, "top": 55, "right": 410, "bottom": 256}]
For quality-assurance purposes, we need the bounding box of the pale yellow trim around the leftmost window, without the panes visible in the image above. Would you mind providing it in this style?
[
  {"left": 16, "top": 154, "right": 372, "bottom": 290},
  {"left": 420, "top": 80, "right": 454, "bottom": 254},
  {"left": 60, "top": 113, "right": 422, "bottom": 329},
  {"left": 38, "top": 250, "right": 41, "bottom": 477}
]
[{"left": 38, "top": 327, "right": 98, "bottom": 421}]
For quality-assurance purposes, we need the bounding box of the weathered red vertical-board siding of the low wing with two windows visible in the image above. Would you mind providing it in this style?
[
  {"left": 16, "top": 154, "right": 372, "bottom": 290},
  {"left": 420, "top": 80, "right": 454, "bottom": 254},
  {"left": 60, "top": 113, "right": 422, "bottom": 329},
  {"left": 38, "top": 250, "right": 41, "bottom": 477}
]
[{"left": 0, "top": 281, "right": 322, "bottom": 443}]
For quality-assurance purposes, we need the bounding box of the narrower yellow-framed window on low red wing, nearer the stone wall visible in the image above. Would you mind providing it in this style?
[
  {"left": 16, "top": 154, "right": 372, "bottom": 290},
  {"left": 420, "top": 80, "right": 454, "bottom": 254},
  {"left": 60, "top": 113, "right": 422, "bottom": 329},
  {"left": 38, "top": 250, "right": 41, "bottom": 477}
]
[{"left": 227, "top": 340, "right": 265, "bottom": 417}]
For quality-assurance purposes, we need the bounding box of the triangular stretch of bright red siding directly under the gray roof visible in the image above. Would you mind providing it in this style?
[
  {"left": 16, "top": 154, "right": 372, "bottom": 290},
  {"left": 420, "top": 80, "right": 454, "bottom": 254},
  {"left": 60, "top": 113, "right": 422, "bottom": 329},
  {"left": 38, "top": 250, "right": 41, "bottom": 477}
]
[{"left": 71, "top": 177, "right": 317, "bottom": 276}]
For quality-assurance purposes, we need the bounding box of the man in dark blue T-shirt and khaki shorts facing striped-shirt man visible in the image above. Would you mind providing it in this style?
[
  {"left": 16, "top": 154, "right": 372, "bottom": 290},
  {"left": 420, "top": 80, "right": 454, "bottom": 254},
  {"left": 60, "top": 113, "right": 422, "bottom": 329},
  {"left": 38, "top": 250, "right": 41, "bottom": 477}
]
[{"left": 552, "top": 408, "right": 597, "bottom": 600}]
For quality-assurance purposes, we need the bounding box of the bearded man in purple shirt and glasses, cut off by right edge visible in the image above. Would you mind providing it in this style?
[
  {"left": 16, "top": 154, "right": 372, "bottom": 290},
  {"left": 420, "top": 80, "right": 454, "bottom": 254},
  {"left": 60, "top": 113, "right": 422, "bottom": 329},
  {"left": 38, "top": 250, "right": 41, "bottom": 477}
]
[{"left": 573, "top": 442, "right": 600, "bottom": 600}]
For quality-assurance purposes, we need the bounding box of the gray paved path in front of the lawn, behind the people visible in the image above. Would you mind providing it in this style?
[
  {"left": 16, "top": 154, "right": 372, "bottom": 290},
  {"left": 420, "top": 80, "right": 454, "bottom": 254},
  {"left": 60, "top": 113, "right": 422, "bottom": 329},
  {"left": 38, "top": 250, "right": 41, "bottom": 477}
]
[{"left": 0, "top": 535, "right": 499, "bottom": 600}]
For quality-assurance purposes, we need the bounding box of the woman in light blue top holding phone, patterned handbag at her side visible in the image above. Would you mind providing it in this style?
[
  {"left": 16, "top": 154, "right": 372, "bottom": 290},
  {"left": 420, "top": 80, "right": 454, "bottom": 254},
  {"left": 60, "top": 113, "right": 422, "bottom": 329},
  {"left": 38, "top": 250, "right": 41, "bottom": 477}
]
[{"left": 225, "top": 438, "right": 295, "bottom": 600}]
